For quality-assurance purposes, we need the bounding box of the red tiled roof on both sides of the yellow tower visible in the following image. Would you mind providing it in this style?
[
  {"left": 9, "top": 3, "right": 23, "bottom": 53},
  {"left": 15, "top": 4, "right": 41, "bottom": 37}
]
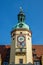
[{"left": 0, "top": 45, "right": 43, "bottom": 61}]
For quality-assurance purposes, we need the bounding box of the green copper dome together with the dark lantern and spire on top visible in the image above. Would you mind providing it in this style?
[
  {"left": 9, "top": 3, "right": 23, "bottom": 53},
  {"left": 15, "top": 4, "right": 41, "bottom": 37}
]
[{"left": 12, "top": 8, "right": 29, "bottom": 30}]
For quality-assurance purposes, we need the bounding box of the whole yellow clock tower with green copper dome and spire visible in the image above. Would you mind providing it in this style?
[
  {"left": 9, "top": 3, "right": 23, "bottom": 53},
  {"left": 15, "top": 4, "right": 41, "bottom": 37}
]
[{"left": 10, "top": 8, "right": 33, "bottom": 64}]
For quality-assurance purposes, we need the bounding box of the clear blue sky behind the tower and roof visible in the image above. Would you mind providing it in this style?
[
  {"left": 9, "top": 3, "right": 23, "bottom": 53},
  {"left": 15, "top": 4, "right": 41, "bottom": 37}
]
[{"left": 0, "top": 0, "right": 43, "bottom": 45}]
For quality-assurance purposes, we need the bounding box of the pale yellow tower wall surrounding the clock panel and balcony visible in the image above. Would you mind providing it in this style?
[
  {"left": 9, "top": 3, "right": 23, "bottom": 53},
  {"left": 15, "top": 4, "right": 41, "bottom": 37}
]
[{"left": 10, "top": 30, "right": 33, "bottom": 64}]
